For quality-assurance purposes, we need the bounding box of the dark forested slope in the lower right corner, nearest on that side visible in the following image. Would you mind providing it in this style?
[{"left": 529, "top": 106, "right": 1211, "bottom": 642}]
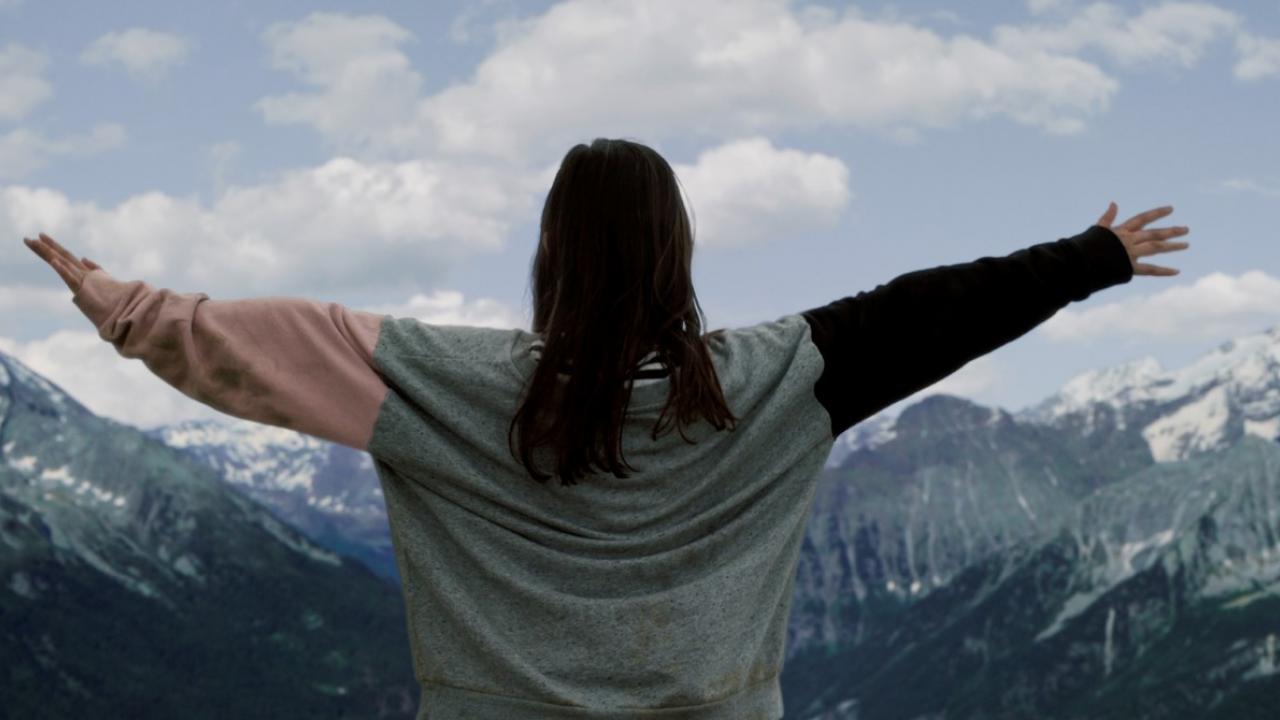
[{"left": 783, "top": 436, "right": 1280, "bottom": 720}]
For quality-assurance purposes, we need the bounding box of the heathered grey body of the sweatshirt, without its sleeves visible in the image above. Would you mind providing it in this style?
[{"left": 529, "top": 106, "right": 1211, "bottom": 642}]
[{"left": 369, "top": 315, "right": 833, "bottom": 719}]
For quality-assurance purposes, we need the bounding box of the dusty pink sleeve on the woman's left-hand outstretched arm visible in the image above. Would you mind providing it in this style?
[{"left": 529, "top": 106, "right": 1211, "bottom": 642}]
[{"left": 72, "top": 269, "right": 388, "bottom": 450}]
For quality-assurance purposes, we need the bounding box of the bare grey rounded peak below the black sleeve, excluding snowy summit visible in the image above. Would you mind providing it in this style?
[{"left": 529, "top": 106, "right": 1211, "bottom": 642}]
[{"left": 787, "top": 395, "right": 1152, "bottom": 657}]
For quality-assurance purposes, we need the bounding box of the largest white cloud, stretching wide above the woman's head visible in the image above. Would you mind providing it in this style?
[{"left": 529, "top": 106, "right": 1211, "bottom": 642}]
[{"left": 259, "top": 0, "right": 1117, "bottom": 159}]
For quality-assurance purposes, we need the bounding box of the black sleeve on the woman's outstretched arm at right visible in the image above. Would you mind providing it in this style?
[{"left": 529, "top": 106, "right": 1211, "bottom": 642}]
[{"left": 801, "top": 225, "right": 1133, "bottom": 437}]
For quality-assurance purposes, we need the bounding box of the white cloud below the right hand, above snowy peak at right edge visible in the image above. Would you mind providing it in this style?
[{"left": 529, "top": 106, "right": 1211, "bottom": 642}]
[{"left": 1039, "top": 270, "right": 1280, "bottom": 342}]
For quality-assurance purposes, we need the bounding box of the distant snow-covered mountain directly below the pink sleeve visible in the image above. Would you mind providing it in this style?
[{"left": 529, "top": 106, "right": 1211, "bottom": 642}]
[{"left": 146, "top": 416, "right": 399, "bottom": 584}]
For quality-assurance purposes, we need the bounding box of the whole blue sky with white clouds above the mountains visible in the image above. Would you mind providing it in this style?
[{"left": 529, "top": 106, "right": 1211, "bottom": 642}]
[{"left": 0, "top": 0, "right": 1280, "bottom": 428}]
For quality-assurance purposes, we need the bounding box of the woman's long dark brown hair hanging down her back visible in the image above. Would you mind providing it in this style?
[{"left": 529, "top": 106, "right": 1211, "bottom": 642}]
[{"left": 507, "top": 138, "right": 737, "bottom": 486}]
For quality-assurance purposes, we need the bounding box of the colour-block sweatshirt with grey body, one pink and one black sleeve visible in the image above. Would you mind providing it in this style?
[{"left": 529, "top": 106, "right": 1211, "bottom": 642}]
[{"left": 73, "top": 225, "right": 1133, "bottom": 720}]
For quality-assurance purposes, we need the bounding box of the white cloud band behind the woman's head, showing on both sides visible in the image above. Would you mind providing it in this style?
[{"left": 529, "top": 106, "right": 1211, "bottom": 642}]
[{"left": 0, "top": 132, "right": 851, "bottom": 295}]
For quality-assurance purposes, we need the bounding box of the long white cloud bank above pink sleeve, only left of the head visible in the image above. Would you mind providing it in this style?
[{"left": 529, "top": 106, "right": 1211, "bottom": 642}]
[{"left": 0, "top": 158, "right": 545, "bottom": 293}]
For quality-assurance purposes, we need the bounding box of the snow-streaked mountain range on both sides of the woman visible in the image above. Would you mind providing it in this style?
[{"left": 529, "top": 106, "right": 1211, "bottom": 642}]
[{"left": 0, "top": 327, "right": 1280, "bottom": 720}]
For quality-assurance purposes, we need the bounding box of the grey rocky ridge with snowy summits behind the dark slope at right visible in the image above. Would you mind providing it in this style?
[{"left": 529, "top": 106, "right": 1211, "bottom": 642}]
[{"left": 787, "top": 325, "right": 1280, "bottom": 657}]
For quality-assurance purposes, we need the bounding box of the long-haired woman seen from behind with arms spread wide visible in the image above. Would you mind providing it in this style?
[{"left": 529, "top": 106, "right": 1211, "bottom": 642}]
[{"left": 27, "top": 138, "right": 1188, "bottom": 720}]
